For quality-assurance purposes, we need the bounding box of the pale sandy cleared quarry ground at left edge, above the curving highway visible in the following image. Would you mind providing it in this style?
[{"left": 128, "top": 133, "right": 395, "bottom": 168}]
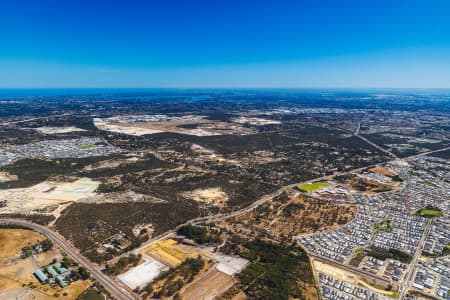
[{"left": 0, "top": 178, "right": 100, "bottom": 213}]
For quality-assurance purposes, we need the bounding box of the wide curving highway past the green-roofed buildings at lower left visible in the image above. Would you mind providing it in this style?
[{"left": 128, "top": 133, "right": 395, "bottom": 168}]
[{"left": 0, "top": 219, "right": 136, "bottom": 300}]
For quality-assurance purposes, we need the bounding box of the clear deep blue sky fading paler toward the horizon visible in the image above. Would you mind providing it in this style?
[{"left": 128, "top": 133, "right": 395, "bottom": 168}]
[{"left": 0, "top": 0, "right": 450, "bottom": 88}]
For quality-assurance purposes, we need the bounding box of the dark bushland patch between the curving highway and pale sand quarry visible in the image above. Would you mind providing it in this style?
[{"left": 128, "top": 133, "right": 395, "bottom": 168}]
[{"left": 55, "top": 200, "right": 199, "bottom": 262}]
